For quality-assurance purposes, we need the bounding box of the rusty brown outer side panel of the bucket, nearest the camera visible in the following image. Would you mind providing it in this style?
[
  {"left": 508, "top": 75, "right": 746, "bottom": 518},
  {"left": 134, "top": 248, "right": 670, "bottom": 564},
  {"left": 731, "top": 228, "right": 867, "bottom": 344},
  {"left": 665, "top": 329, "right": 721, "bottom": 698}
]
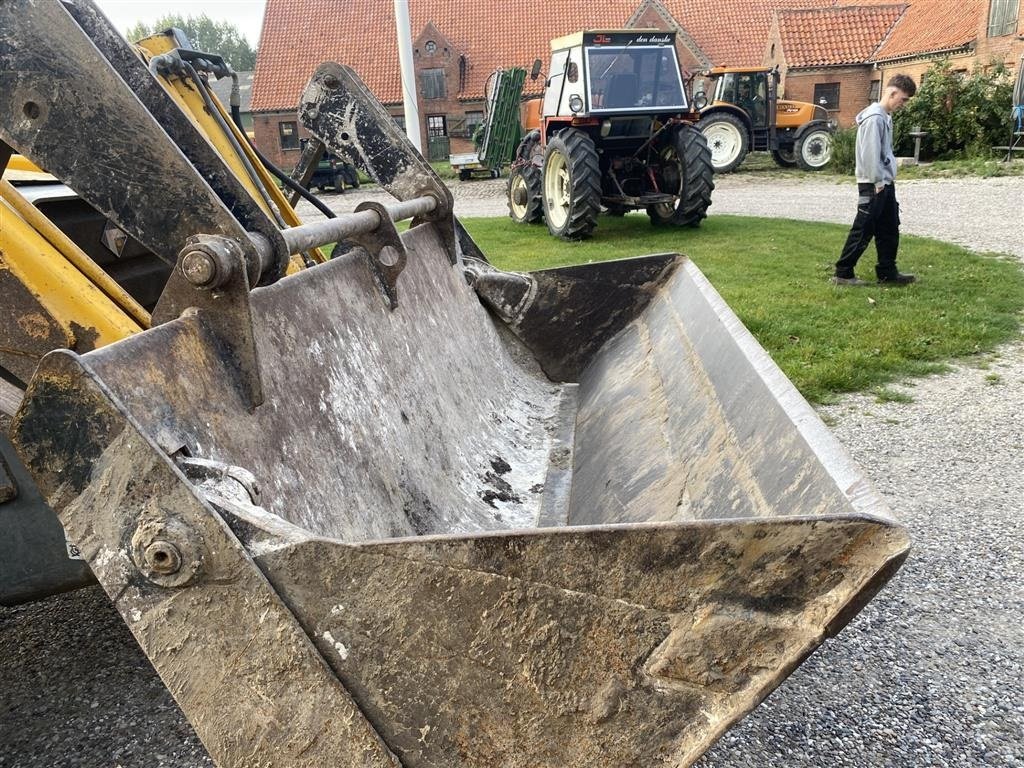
[{"left": 247, "top": 517, "right": 905, "bottom": 768}]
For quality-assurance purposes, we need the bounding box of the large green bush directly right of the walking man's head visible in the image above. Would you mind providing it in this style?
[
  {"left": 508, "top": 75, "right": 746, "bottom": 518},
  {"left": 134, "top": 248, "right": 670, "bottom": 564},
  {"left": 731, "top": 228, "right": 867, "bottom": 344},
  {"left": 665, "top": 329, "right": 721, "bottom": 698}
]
[{"left": 892, "top": 61, "right": 1013, "bottom": 162}]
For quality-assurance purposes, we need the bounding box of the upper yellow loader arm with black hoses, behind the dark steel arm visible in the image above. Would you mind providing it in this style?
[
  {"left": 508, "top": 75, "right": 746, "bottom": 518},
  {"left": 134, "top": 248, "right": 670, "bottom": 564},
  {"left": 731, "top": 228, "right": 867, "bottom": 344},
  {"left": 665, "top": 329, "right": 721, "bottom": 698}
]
[{"left": 135, "top": 35, "right": 327, "bottom": 273}]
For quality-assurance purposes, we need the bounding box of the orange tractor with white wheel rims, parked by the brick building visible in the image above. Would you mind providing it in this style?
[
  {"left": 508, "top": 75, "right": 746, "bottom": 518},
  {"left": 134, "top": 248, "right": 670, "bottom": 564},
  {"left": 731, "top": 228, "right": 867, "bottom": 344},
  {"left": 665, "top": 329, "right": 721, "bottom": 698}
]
[{"left": 697, "top": 68, "right": 835, "bottom": 173}]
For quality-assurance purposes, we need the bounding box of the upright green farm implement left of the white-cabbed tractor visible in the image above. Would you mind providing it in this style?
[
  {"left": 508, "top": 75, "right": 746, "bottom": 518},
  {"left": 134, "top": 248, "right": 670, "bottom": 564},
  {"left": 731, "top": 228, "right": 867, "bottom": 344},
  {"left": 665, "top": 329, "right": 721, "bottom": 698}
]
[{"left": 449, "top": 67, "right": 526, "bottom": 181}]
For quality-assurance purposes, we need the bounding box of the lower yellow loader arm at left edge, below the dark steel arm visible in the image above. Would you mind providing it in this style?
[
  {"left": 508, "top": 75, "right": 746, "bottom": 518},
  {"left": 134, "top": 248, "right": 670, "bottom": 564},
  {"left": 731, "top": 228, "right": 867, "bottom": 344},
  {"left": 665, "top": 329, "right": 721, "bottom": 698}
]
[{"left": 0, "top": 196, "right": 142, "bottom": 347}]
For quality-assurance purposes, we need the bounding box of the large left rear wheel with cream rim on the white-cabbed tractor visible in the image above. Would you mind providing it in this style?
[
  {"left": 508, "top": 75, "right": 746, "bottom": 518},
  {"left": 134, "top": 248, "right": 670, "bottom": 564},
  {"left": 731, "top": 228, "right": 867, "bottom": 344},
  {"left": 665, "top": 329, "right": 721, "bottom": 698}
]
[{"left": 542, "top": 128, "right": 601, "bottom": 240}]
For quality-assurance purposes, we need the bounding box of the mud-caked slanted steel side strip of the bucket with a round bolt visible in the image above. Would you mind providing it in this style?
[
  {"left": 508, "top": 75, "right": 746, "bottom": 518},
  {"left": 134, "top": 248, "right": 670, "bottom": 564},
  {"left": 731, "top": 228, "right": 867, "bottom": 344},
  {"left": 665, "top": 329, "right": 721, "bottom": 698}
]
[{"left": 15, "top": 351, "right": 398, "bottom": 768}]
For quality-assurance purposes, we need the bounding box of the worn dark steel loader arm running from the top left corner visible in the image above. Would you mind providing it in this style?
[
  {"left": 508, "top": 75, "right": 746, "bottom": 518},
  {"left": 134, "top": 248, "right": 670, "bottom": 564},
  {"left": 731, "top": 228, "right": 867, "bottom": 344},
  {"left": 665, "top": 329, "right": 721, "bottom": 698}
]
[{"left": 0, "top": 0, "right": 258, "bottom": 276}]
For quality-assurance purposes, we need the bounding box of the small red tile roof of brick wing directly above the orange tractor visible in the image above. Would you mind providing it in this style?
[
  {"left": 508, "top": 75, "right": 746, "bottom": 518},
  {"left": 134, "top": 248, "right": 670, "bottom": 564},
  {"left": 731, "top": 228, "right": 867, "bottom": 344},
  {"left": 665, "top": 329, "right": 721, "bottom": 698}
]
[{"left": 777, "top": 4, "right": 906, "bottom": 67}]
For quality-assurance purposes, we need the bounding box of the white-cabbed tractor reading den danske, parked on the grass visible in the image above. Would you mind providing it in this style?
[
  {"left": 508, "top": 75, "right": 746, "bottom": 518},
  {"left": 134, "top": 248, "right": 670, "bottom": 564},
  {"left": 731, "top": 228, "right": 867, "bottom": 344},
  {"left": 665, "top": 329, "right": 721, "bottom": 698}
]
[{"left": 508, "top": 30, "right": 715, "bottom": 240}]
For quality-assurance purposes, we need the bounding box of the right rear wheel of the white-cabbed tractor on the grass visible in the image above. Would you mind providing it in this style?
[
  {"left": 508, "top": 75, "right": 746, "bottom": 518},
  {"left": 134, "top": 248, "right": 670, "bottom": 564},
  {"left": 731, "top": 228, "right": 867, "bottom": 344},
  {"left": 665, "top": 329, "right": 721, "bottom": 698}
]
[{"left": 647, "top": 125, "right": 715, "bottom": 226}]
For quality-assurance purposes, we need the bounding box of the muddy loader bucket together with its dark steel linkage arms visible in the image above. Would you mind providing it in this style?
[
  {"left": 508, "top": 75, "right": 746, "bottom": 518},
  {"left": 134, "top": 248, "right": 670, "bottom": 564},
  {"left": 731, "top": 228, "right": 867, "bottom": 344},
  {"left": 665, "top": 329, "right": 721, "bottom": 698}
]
[{"left": 0, "top": 0, "right": 908, "bottom": 768}]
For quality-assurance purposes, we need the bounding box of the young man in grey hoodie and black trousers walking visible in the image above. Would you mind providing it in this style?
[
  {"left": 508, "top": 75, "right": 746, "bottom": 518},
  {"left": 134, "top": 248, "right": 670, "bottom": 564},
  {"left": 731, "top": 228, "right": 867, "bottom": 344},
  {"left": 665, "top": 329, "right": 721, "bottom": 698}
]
[{"left": 833, "top": 75, "right": 918, "bottom": 286}]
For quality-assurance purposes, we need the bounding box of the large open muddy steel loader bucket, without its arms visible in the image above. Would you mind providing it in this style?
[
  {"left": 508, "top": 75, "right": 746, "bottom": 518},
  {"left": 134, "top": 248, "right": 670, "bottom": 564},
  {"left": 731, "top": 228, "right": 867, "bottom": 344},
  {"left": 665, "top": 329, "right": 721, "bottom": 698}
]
[{"left": 6, "top": 205, "right": 907, "bottom": 768}]
